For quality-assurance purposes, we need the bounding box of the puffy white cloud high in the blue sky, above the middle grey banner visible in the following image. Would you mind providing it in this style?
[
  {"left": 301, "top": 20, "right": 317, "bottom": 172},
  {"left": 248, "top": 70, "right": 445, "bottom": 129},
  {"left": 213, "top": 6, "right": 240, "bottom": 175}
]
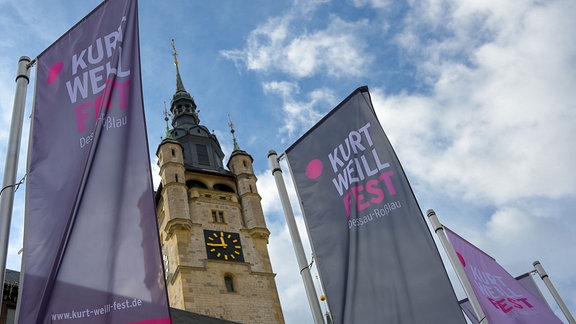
[{"left": 221, "top": 12, "right": 372, "bottom": 78}]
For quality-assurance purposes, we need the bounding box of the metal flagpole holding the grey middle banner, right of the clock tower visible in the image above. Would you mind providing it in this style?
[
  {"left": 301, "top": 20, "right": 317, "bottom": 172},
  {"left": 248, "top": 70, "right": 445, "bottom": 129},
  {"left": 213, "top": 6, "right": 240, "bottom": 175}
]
[{"left": 268, "top": 150, "right": 324, "bottom": 324}]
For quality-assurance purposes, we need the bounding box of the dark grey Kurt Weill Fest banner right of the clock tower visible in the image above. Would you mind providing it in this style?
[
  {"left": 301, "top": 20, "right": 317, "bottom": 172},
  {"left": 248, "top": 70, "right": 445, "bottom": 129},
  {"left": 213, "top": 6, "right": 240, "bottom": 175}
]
[{"left": 286, "top": 87, "right": 465, "bottom": 323}]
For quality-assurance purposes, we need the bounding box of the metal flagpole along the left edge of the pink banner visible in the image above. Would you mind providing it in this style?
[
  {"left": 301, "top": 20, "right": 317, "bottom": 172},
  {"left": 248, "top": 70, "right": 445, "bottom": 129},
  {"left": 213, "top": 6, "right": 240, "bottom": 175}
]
[{"left": 426, "top": 209, "right": 488, "bottom": 324}]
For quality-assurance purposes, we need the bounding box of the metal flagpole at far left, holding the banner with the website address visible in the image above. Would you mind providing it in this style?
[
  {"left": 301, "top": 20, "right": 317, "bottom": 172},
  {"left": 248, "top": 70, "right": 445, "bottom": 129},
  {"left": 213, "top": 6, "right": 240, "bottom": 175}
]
[{"left": 0, "top": 56, "right": 32, "bottom": 301}]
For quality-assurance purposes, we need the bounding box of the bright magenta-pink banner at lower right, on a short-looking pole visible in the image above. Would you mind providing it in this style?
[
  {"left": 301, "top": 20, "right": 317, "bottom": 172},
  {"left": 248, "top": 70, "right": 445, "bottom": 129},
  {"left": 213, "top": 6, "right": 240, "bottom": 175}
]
[{"left": 444, "top": 227, "right": 562, "bottom": 324}]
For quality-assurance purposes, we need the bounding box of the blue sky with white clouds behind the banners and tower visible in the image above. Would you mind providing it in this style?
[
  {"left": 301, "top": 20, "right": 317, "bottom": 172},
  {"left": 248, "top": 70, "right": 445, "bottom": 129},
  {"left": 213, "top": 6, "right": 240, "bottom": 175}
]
[{"left": 0, "top": 0, "right": 576, "bottom": 323}]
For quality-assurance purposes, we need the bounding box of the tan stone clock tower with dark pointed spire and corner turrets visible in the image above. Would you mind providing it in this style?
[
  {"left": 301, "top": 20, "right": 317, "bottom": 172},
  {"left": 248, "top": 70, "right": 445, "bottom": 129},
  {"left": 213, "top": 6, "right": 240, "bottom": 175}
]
[{"left": 156, "top": 43, "right": 284, "bottom": 324}]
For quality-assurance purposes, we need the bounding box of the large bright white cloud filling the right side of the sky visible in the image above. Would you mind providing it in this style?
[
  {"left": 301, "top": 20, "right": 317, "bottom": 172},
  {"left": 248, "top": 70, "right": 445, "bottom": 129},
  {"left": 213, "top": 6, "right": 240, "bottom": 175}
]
[{"left": 374, "top": 2, "right": 576, "bottom": 203}]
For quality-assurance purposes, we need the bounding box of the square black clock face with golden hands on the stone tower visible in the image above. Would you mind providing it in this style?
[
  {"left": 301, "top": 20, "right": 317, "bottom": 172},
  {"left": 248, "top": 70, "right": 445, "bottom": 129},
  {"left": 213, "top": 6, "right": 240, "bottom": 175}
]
[{"left": 204, "top": 230, "right": 244, "bottom": 262}]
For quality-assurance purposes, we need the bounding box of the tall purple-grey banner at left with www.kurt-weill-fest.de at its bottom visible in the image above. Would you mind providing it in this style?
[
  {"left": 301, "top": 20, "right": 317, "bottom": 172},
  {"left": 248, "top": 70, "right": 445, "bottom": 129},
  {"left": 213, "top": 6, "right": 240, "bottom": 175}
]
[{"left": 19, "top": 0, "right": 171, "bottom": 324}]
